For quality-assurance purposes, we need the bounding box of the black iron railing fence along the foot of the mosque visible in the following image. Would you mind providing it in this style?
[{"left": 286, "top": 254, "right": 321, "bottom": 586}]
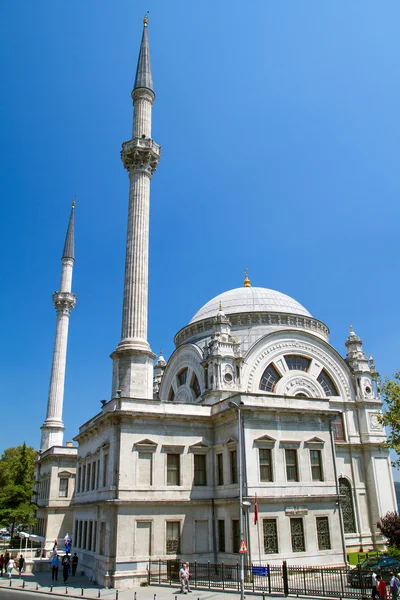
[{"left": 149, "top": 560, "right": 371, "bottom": 600}]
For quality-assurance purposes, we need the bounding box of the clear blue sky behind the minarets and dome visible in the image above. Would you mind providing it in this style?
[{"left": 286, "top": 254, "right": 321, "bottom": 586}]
[{"left": 0, "top": 0, "right": 400, "bottom": 474}]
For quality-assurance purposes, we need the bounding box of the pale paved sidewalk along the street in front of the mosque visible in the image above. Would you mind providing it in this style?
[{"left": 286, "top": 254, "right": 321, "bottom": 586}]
[{"left": 0, "top": 573, "right": 276, "bottom": 600}]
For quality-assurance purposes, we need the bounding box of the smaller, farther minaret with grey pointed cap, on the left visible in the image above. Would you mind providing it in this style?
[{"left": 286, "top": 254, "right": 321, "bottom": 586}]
[{"left": 40, "top": 200, "right": 76, "bottom": 451}]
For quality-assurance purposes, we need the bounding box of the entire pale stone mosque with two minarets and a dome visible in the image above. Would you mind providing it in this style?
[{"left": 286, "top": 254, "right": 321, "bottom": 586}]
[{"left": 35, "top": 19, "right": 396, "bottom": 588}]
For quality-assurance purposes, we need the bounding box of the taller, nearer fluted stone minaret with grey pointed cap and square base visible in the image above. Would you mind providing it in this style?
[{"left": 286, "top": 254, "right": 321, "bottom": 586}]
[{"left": 111, "top": 17, "right": 161, "bottom": 398}]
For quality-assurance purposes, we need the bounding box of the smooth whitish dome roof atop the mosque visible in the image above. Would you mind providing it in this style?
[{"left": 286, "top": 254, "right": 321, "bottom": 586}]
[{"left": 190, "top": 287, "right": 312, "bottom": 323}]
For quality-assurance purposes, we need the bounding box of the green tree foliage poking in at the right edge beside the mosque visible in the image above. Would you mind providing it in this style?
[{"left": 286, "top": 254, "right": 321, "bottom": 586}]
[{"left": 379, "top": 371, "right": 400, "bottom": 467}]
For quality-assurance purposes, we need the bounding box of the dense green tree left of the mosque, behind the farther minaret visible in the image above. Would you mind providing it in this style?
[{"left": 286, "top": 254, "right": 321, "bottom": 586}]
[{"left": 0, "top": 442, "right": 36, "bottom": 532}]
